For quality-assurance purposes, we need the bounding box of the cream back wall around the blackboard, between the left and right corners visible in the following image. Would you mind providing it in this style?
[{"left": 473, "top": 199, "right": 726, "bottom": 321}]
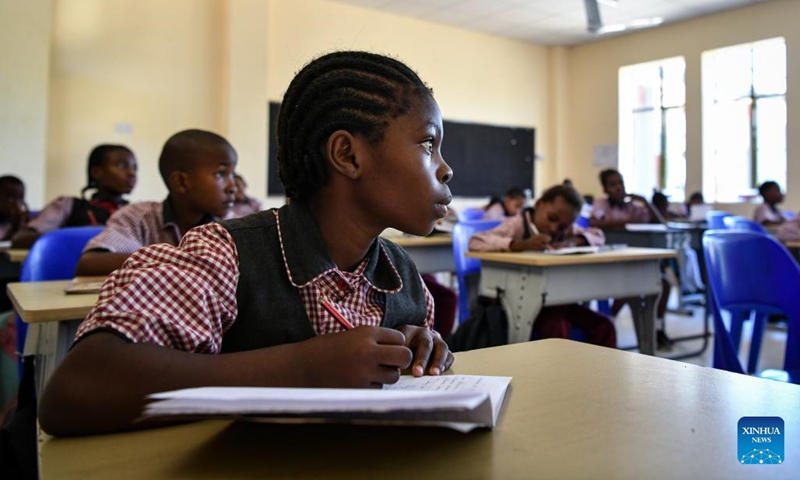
[{"left": 25, "top": 0, "right": 549, "bottom": 210}]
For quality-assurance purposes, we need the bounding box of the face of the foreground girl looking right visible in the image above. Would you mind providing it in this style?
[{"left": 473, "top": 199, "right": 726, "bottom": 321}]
[{"left": 357, "top": 95, "right": 453, "bottom": 235}]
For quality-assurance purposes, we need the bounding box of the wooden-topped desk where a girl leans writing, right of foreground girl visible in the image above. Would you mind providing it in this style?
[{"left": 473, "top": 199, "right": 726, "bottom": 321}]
[{"left": 467, "top": 248, "right": 675, "bottom": 355}]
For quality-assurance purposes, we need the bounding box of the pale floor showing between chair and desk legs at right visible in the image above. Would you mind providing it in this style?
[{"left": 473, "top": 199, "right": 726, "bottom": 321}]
[{"left": 615, "top": 288, "right": 786, "bottom": 371}]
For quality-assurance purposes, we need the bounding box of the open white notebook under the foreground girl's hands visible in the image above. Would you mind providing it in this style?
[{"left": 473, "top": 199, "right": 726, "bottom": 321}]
[{"left": 141, "top": 375, "right": 511, "bottom": 432}]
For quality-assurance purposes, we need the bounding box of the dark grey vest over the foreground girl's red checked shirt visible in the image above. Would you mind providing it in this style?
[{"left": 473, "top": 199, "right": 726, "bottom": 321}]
[{"left": 221, "top": 203, "right": 427, "bottom": 353}]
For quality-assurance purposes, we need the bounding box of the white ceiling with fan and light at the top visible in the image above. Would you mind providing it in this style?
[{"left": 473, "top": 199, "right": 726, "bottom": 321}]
[{"left": 334, "top": 0, "right": 771, "bottom": 45}]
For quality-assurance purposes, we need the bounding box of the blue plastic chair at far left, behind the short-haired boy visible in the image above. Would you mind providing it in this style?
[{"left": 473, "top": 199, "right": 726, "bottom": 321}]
[{"left": 17, "top": 226, "right": 104, "bottom": 376}]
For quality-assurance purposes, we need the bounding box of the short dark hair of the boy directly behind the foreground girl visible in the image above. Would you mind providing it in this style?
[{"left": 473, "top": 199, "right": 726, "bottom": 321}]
[{"left": 158, "top": 129, "right": 234, "bottom": 189}]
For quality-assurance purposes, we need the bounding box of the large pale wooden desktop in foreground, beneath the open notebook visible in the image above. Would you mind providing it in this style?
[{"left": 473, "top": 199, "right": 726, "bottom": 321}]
[{"left": 40, "top": 339, "right": 800, "bottom": 480}]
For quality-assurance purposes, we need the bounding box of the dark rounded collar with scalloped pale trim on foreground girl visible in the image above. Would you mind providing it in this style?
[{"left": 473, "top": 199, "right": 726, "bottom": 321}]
[{"left": 275, "top": 200, "right": 403, "bottom": 293}]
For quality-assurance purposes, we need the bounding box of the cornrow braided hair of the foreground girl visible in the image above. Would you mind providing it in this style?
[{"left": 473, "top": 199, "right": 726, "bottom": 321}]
[{"left": 277, "top": 51, "right": 433, "bottom": 199}]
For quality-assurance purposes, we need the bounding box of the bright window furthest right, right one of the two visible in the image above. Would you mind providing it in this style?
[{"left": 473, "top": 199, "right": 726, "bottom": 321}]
[{"left": 703, "top": 38, "right": 786, "bottom": 202}]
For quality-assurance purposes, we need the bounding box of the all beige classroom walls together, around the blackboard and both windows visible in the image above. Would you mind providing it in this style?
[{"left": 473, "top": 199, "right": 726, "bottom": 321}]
[{"left": 6, "top": 0, "right": 800, "bottom": 212}]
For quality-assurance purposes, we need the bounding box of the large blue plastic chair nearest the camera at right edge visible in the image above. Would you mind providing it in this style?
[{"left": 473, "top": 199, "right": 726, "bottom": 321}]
[{"left": 703, "top": 231, "right": 800, "bottom": 383}]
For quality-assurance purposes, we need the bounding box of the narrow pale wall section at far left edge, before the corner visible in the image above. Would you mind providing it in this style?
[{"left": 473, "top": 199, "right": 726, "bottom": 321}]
[{"left": 0, "top": 0, "right": 51, "bottom": 209}]
